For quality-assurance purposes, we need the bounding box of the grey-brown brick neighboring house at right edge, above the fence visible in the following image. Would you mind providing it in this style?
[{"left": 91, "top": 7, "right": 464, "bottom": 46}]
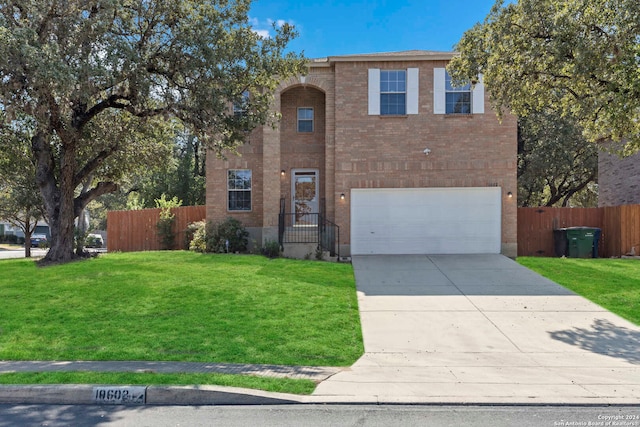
[{"left": 598, "top": 147, "right": 640, "bottom": 206}]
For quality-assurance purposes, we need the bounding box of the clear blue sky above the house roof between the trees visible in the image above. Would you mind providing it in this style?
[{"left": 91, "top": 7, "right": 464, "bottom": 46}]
[{"left": 249, "top": 0, "right": 495, "bottom": 58}]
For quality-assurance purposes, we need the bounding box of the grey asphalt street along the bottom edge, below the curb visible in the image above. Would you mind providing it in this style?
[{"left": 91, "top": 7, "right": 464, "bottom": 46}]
[{"left": 0, "top": 405, "right": 640, "bottom": 427}]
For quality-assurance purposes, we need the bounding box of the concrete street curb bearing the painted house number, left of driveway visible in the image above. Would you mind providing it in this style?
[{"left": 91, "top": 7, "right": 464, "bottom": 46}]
[{"left": 0, "top": 384, "right": 307, "bottom": 406}]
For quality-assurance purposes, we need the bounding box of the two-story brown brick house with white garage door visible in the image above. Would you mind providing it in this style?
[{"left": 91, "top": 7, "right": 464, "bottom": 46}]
[{"left": 207, "top": 51, "right": 517, "bottom": 257}]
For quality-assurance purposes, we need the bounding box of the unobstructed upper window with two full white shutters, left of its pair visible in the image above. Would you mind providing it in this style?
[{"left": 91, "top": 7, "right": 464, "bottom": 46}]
[{"left": 368, "top": 68, "right": 419, "bottom": 116}]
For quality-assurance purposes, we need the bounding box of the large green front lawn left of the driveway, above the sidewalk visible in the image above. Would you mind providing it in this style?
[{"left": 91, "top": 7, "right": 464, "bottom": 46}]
[{"left": 0, "top": 252, "right": 363, "bottom": 394}]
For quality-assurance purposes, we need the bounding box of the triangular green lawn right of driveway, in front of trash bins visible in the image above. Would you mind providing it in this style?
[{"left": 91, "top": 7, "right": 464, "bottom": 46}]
[{"left": 518, "top": 257, "right": 640, "bottom": 325}]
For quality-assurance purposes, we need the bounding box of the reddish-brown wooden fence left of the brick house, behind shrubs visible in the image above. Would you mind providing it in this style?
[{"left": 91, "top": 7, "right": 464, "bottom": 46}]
[{"left": 107, "top": 206, "right": 207, "bottom": 252}]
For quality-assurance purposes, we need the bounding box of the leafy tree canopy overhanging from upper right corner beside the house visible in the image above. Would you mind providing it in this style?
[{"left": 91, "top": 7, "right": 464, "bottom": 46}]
[{"left": 449, "top": 0, "right": 640, "bottom": 151}]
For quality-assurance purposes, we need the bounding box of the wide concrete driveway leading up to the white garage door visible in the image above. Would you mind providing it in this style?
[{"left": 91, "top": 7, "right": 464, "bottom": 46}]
[{"left": 314, "top": 255, "right": 640, "bottom": 404}]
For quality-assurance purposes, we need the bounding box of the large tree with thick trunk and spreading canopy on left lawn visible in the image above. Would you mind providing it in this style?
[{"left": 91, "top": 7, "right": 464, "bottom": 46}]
[{"left": 0, "top": 0, "right": 304, "bottom": 262}]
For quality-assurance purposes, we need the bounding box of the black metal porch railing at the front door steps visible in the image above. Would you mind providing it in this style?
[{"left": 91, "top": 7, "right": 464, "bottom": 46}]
[{"left": 278, "top": 199, "right": 340, "bottom": 257}]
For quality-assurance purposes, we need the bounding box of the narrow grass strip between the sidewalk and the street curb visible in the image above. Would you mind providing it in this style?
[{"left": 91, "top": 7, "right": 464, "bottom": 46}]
[{"left": 0, "top": 372, "right": 316, "bottom": 395}]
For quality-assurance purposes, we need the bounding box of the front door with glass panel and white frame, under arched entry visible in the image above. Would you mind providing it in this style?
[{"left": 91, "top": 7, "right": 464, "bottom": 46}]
[{"left": 291, "top": 169, "right": 320, "bottom": 226}]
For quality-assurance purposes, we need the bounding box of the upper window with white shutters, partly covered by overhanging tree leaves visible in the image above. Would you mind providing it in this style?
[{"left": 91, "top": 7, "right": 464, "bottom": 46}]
[{"left": 433, "top": 68, "right": 484, "bottom": 115}]
